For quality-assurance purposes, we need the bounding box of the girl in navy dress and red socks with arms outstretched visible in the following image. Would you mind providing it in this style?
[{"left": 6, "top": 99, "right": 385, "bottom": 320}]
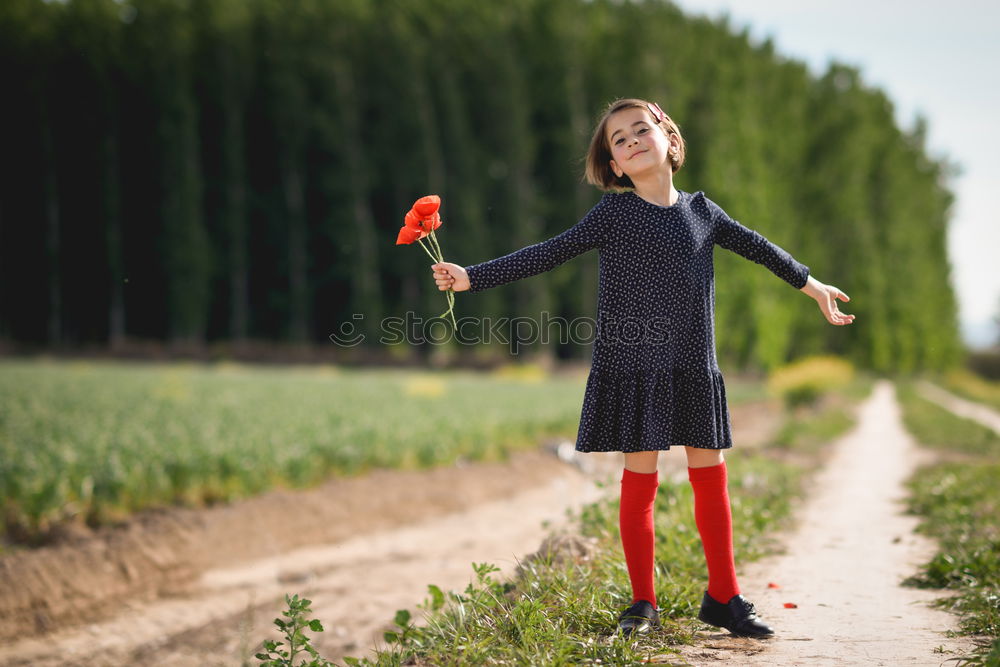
[{"left": 431, "top": 99, "right": 854, "bottom": 637}]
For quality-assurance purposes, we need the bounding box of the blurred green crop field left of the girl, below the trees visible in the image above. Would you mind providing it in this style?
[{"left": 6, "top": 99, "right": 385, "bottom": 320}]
[{"left": 0, "top": 360, "right": 584, "bottom": 542}]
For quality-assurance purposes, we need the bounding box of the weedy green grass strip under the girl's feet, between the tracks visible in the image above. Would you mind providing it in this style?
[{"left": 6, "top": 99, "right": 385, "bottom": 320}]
[{"left": 346, "top": 381, "right": 871, "bottom": 666}]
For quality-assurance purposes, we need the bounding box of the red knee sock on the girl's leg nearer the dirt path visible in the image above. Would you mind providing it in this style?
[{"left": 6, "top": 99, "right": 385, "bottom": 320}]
[{"left": 688, "top": 461, "right": 740, "bottom": 603}]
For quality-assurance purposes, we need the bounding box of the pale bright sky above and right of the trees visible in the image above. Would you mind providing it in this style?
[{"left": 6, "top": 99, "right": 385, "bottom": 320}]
[{"left": 674, "top": 0, "right": 1000, "bottom": 347}]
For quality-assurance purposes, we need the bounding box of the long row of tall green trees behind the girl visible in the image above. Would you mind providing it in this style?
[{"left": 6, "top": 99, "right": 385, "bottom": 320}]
[{"left": 0, "top": 0, "right": 961, "bottom": 371}]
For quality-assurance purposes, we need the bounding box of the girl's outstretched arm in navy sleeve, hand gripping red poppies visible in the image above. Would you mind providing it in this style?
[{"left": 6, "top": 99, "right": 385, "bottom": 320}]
[{"left": 431, "top": 200, "right": 607, "bottom": 292}]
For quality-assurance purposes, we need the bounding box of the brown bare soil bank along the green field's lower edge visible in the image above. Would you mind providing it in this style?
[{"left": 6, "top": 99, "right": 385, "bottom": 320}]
[{"left": 0, "top": 452, "right": 566, "bottom": 641}]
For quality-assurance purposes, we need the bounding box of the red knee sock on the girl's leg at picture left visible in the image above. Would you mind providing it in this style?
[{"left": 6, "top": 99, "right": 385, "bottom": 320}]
[{"left": 618, "top": 468, "right": 660, "bottom": 607}]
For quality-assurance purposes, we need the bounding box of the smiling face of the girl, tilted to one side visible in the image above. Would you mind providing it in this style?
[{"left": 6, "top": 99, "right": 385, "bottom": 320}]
[{"left": 607, "top": 107, "right": 680, "bottom": 182}]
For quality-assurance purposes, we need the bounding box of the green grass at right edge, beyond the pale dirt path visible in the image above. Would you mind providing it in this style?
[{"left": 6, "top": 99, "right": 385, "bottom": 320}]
[{"left": 899, "top": 384, "right": 1000, "bottom": 665}]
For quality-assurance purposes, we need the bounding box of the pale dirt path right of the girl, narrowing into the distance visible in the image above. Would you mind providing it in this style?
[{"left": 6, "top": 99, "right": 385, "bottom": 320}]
[{"left": 685, "top": 380, "right": 972, "bottom": 666}]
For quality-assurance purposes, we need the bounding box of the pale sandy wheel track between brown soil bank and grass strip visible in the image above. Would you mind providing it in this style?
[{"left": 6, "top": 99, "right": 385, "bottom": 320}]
[{"left": 4, "top": 466, "right": 600, "bottom": 667}]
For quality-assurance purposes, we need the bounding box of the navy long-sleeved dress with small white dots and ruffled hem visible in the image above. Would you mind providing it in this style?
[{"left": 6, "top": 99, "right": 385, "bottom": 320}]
[{"left": 466, "top": 191, "right": 809, "bottom": 452}]
